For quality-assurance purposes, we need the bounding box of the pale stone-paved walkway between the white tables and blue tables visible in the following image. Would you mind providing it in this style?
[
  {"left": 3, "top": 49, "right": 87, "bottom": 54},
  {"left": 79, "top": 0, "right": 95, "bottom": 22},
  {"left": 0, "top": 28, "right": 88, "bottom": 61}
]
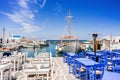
[{"left": 52, "top": 57, "right": 78, "bottom": 80}]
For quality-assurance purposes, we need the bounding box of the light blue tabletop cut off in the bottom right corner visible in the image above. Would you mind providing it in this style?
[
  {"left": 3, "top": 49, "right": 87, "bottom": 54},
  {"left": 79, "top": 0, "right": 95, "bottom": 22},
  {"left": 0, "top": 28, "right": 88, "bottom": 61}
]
[{"left": 102, "top": 71, "right": 120, "bottom": 80}]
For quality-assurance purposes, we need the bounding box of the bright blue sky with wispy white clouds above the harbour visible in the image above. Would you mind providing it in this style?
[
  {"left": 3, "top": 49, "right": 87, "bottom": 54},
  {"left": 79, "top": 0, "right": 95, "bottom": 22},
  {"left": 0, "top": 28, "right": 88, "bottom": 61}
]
[{"left": 0, "top": 0, "right": 120, "bottom": 40}]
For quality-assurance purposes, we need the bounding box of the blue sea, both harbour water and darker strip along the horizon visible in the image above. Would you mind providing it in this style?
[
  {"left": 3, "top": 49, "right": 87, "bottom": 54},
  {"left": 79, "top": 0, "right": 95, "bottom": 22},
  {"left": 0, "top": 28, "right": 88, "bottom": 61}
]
[{"left": 20, "top": 40, "right": 87, "bottom": 57}]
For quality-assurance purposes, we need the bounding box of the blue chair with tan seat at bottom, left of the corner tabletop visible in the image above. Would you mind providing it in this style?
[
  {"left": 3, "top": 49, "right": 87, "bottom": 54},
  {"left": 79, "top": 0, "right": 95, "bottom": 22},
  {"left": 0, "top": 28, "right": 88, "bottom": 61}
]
[{"left": 89, "top": 64, "right": 104, "bottom": 80}]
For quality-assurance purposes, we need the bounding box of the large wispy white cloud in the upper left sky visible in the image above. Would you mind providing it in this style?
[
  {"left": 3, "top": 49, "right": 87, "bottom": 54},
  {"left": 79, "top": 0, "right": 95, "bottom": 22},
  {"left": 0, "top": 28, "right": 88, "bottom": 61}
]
[{"left": 0, "top": 0, "right": 40, "bottom": 33}]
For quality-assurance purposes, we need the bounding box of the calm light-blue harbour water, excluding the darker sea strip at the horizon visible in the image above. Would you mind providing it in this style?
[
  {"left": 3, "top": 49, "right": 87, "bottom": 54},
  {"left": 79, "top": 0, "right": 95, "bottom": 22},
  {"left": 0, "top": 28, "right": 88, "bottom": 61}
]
[{"left": 21, "top": 44, "right": 57, "bottom": 57}]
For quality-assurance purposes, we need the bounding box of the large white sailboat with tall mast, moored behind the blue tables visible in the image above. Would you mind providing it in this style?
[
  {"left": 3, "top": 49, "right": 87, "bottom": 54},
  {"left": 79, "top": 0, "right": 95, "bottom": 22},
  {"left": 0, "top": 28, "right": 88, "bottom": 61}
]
[{"left": 56, "top": 10, "right": 81, "bottom": 53}]
